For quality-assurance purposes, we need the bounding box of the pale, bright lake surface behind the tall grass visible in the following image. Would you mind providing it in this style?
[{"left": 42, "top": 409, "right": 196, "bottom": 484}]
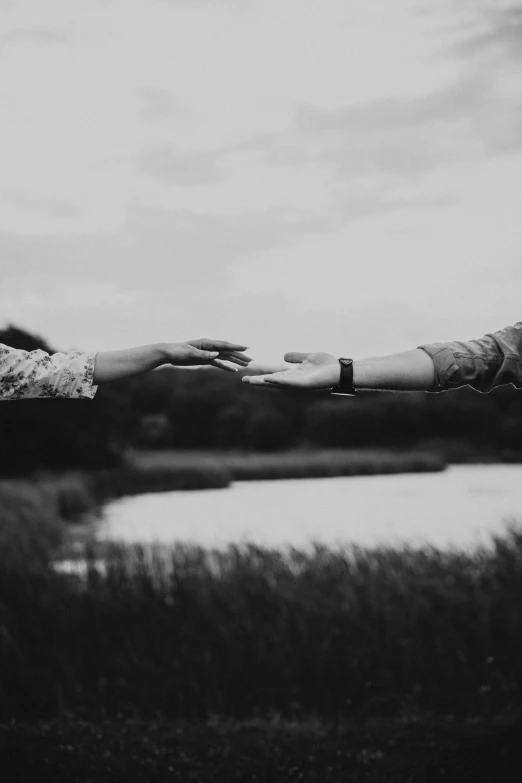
[{"left": 96, "top": 465, "right": 522, "bottom": 548}]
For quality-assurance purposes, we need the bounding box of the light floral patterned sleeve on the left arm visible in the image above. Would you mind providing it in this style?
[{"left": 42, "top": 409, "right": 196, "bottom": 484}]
[{"left": 0, "top": 343, "right": 97, "bottom": 400}]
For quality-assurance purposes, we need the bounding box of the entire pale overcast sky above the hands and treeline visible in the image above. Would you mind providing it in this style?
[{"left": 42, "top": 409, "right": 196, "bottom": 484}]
[{"left": 0, "top": 0, "right": 522, "bottom": 359}]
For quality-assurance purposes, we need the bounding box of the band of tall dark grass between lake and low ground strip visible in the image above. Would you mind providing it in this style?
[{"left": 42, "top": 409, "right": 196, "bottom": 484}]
[{"left": 0, "top": 502, "right": 522, "bottom": 719}]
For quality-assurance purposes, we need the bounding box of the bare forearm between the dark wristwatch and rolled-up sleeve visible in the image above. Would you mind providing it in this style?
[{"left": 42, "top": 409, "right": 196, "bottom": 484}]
[{"left": 353, "top": 348, "right": 435, "bottom": 391}]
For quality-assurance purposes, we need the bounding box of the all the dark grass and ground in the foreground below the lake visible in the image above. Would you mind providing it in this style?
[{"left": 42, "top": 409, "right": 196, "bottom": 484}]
[{"left": 0, "top": 482, "right": 522, "bottom": 783}]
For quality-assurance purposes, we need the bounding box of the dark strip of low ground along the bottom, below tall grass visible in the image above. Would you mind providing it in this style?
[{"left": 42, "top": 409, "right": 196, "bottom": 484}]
[{"left": 0, "top": 715, "right": 522, "bottom": 783}]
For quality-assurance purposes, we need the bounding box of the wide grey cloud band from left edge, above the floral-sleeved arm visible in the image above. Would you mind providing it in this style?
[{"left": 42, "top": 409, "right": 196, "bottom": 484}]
[{"left": 0, "top": 202, "right": 330, "bottom": 290}]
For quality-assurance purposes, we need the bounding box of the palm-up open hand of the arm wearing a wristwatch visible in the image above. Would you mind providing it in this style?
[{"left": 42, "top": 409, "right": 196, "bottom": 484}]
[{"left": 242, "top": 353, "right": 340, "bottom": 391}]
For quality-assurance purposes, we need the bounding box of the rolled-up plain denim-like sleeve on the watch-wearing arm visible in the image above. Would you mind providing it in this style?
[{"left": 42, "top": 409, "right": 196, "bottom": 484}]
[{"left": 419, "top": 321, "right": 522, "bottom": 392}]
